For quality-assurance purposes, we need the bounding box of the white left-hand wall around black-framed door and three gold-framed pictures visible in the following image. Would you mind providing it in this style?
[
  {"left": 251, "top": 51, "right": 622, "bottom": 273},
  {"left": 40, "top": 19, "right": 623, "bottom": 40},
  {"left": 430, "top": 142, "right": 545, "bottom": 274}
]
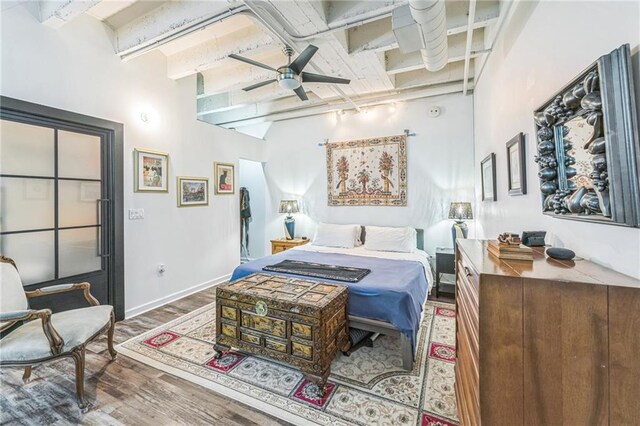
[{"left": 0, "top": 3, "right": 264, "bottom": 315}]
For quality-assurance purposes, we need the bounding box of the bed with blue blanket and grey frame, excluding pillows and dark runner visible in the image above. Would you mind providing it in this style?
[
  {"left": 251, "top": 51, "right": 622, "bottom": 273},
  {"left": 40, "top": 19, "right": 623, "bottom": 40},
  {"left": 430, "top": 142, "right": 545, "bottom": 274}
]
[{"left": 231, "top": 229, "right": 433, "bottom": 370}]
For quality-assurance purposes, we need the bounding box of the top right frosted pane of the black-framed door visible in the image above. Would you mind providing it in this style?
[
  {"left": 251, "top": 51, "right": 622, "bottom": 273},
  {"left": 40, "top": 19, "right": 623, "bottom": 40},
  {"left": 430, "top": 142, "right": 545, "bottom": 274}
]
[{"left": 58, "top": 130, "right": 101, "bottom": 179}]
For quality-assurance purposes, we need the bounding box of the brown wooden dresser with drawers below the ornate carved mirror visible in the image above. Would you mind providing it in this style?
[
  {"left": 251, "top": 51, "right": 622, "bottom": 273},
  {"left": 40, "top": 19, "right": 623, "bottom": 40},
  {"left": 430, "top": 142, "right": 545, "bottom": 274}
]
[{"left": 455, "top": 239, "right": 640, "bottom": 426}]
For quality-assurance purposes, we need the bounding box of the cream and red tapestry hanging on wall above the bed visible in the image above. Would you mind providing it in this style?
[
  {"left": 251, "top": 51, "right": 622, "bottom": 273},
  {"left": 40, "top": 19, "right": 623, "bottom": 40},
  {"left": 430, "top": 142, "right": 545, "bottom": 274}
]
[{"left": 327, "top": 135, "right": 407, "bottom": 206}]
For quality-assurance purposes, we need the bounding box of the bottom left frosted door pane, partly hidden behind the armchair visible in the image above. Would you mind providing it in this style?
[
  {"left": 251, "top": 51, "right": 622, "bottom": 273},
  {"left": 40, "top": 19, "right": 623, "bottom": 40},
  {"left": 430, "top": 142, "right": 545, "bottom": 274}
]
[{"left": 0, "top": 231, "right": 55, "bottom": 285}]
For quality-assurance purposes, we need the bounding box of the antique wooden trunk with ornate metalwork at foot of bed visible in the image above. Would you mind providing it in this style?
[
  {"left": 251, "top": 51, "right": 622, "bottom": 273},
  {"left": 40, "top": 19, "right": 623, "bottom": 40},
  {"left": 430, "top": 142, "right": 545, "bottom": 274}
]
[{"left": 216, "top": 274, "right": 349, "bottom": 388}]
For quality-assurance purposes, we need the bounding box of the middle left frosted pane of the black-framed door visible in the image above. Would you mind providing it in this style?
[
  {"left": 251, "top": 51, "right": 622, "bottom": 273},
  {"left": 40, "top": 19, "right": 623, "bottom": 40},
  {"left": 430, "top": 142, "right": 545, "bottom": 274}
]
[{"left": 0, "top": 177, "right": 54, "bottom": 232}]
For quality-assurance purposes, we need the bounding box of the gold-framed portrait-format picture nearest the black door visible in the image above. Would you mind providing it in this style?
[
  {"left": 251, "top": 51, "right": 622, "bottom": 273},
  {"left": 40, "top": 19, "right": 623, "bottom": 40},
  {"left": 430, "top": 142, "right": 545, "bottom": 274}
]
[{"left": 133, "top": 148, "right": 169, "bottom": 192}]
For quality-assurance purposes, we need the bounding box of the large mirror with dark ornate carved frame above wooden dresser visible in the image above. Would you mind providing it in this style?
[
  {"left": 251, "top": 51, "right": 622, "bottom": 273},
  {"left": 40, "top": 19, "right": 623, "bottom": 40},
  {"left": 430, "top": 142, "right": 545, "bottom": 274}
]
[{"left": 534, "top": 44, "right": 640, "bottom": 227}]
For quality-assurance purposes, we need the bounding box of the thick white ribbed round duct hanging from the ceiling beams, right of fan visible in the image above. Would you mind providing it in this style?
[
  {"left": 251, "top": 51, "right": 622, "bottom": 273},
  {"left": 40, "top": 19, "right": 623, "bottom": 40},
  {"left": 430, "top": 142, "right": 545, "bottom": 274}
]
[{"left": 409, "top": 0, "right": 449, "bottom": 72}]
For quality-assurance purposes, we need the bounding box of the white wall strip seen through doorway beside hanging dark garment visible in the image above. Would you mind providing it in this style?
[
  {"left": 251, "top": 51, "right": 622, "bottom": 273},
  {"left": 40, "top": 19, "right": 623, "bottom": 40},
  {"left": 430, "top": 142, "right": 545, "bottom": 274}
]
[{"left": 238, "top": 159, "right": 271, "bottom": 259}]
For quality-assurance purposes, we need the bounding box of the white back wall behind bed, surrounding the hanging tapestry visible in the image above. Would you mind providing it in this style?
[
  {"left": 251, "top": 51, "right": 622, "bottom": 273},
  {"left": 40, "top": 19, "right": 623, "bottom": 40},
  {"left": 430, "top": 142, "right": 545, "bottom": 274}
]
[{"left": 265, "top": 95, "right": 473, "bottom": 253}]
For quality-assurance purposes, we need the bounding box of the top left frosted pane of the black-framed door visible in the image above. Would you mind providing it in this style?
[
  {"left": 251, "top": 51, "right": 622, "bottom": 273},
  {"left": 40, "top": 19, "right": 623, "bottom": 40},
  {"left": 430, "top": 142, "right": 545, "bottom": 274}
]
[{"left": 0, "top": 120, "right": 54, "bottom": 177}]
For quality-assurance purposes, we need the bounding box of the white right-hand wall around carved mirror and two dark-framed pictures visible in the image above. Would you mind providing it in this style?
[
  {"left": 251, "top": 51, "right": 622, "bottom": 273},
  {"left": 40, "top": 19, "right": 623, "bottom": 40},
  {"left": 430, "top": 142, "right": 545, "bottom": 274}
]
[{"left": 474, "top": 1, "right": 640, "bottom": 277}]
